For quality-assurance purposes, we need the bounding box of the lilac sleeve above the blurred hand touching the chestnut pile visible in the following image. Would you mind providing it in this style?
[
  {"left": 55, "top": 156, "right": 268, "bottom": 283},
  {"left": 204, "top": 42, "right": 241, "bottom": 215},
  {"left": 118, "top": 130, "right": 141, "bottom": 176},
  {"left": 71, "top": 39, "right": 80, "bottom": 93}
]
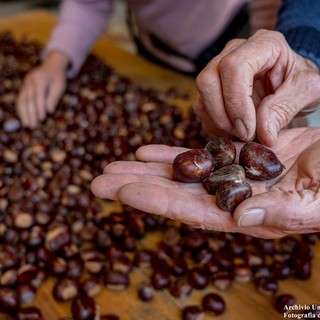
[{"left": 43, "top": 0, "right": 112, "bottom": 77}]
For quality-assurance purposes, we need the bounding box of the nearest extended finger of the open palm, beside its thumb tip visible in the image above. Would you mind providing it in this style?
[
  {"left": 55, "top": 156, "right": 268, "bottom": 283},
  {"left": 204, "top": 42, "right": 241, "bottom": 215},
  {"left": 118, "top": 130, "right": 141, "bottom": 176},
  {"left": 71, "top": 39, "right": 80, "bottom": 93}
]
[{"left": 119, "top": 183, "right": 236, "bottom": 231}]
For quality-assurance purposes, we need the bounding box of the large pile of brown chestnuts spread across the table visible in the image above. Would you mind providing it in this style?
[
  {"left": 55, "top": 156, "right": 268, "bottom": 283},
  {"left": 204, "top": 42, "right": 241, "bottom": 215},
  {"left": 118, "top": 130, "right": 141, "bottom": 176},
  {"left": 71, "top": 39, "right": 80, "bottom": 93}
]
[{"left": 0, "top": 32, "right": 318, "bottom": 320}]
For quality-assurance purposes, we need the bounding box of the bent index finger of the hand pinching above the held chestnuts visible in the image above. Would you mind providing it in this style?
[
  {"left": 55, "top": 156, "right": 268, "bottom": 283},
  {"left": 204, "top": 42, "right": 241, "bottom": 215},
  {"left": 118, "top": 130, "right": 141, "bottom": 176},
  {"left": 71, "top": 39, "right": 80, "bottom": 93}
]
[{"left": 215, "top": 32, "right": 284, "bottom": 140}]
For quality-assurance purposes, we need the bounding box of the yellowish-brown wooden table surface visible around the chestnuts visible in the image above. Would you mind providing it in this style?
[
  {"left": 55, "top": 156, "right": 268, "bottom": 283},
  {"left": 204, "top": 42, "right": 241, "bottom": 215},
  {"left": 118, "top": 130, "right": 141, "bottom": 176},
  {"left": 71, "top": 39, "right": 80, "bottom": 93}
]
[{"left": 0, "top": 11, "right": 320, "bottom": 320}]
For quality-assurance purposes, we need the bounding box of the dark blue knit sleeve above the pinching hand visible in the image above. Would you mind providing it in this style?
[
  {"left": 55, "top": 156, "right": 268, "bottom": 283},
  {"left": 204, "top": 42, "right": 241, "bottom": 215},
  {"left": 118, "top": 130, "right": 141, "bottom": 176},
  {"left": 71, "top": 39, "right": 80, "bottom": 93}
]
[{"left": 277, "top": 0, "right": 320, "bottom": 69}]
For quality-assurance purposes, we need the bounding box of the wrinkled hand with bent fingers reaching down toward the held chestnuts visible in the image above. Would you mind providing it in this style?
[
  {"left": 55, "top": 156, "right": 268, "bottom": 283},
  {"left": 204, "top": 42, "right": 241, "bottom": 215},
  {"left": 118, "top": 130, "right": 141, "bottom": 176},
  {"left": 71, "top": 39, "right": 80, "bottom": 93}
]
[{"left": 194, "top": 30, "right": 320, "bottom": 146}]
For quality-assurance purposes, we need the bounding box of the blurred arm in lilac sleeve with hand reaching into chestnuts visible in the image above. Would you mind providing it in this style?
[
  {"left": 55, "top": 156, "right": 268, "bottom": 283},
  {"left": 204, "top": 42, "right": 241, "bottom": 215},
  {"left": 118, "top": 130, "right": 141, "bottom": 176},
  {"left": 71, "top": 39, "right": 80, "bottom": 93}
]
[{"left": 17, "top": 0, "right": 111, "bottom": 128}]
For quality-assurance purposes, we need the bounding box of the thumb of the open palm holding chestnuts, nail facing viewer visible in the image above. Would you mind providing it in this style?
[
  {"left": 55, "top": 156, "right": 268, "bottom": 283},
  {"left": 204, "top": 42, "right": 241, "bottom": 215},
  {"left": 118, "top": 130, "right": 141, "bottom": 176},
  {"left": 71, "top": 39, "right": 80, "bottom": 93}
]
[{"left": 234, "top": 190, "right": 320, "bottom": 233}]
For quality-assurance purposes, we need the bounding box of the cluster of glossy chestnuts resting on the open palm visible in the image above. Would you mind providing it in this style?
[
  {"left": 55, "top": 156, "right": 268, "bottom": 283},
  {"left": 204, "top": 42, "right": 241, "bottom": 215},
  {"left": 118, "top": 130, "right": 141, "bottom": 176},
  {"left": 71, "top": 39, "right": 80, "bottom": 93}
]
[{"left": 172, "top": 137, "right": 285, "bottom": 212}]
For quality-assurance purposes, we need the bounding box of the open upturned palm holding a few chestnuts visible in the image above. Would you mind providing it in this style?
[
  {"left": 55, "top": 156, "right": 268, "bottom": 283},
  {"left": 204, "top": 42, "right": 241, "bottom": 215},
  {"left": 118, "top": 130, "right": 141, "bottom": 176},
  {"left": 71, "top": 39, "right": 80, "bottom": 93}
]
[{"left": 91, "top": 128, "right": 320, "bottom": 238}]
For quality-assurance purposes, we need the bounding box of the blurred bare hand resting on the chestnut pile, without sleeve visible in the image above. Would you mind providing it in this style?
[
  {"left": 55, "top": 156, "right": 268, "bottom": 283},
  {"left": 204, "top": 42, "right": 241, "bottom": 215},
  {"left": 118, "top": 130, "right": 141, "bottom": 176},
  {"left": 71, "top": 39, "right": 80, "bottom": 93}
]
[{"left": 16, "top": 53, "right": 67, "bottom": 129}]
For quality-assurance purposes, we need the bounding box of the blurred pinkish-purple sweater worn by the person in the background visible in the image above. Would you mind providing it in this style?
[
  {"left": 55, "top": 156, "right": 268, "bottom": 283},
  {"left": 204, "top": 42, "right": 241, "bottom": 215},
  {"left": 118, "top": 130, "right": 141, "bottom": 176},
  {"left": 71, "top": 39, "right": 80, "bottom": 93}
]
[{"left": 44, "top": 0, "right": 279, "bottom": 77}]
